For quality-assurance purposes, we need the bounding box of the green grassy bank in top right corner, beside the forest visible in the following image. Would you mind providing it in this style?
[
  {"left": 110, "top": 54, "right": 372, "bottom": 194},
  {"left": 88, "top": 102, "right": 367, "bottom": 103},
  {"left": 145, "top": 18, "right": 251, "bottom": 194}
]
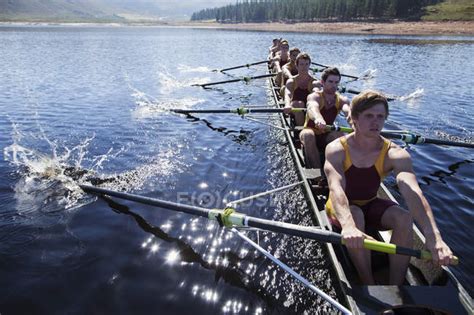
[{"left": 421, "top": 0, "right": 474, "bottom": 21}]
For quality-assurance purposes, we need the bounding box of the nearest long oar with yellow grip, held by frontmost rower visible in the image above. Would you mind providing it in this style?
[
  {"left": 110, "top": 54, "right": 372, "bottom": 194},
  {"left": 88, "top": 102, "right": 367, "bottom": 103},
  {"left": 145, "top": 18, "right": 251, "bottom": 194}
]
[{"left": 79, "top": 185, "right": 458, "bottom": 264}]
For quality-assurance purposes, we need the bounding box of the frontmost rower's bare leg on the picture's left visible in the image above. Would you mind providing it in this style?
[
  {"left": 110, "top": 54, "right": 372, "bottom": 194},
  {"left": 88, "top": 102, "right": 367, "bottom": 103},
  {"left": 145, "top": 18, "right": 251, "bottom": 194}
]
[{"left": 347, "top": 206, "right": 375, "bottom": 285}]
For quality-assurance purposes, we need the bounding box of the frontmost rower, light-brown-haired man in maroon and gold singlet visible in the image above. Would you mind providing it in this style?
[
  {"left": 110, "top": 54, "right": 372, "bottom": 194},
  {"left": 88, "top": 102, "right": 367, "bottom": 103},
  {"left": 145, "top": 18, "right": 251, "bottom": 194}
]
[{"left": 324, "top": 91, "right": 454, "bottom": 285}]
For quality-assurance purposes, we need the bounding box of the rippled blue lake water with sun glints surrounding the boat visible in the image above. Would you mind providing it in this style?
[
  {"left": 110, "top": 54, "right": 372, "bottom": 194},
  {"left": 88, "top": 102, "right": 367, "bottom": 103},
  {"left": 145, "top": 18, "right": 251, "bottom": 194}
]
[{"left": 0, "top": 26, "right": 474, "bottom": 314}]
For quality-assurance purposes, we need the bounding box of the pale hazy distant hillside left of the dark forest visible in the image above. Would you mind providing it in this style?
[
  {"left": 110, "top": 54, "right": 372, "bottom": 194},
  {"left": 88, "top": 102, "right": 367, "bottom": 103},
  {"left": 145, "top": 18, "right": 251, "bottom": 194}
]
[{"left": 0, "top": 0, "right": 232, "bottom": 22}]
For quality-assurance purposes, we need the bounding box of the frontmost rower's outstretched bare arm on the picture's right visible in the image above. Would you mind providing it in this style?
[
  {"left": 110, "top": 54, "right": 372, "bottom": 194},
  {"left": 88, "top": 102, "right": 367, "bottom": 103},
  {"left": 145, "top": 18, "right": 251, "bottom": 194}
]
[{"left": 388, "top": 146, "right": 453, "bottom": 265}]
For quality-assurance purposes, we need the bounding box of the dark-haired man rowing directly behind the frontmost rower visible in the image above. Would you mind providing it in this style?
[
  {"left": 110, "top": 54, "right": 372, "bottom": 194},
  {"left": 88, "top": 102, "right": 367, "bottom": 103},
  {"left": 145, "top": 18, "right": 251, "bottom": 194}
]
[{"left": 300, "top": 68, "right": 350, "bottom": 168}]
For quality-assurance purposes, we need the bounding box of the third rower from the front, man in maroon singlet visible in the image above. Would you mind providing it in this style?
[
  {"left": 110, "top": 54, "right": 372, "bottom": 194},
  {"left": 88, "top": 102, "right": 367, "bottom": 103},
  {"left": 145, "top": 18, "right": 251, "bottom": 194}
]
[{"left": 284, "top": 52, "right": 321, "bottom": 126}]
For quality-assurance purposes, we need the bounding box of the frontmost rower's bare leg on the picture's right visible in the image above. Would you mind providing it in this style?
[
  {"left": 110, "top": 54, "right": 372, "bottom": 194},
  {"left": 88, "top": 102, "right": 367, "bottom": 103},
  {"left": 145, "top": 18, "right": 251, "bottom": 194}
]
[{"left": 380, "top": 206, "right": 413, "bottom": 285}]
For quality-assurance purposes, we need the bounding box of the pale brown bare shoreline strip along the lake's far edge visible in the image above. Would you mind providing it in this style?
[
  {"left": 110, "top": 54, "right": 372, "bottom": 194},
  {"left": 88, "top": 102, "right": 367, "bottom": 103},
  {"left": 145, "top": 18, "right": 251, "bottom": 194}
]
[{"left": 0, "top": 21, "right": 474, "bottom": 36}]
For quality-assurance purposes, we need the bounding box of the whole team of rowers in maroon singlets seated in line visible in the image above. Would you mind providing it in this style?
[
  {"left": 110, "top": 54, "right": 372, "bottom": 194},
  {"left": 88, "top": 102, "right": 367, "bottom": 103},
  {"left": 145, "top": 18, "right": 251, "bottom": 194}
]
[{"left": 269, "top": 39, "right": 454, "bottom": 285}]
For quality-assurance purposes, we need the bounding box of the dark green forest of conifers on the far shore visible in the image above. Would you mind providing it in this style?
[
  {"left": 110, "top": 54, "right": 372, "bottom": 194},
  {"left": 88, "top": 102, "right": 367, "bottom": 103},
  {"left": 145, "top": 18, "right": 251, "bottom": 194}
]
[{"left": 191, "top": 0, "right": 441, "bottom": 23}]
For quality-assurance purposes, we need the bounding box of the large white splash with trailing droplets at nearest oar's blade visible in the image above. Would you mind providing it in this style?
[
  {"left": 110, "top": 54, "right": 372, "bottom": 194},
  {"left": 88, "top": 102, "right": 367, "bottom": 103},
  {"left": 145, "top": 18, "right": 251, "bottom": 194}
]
[{"left": 3, "top": 123, "right": 186, "bottom": 214}]
